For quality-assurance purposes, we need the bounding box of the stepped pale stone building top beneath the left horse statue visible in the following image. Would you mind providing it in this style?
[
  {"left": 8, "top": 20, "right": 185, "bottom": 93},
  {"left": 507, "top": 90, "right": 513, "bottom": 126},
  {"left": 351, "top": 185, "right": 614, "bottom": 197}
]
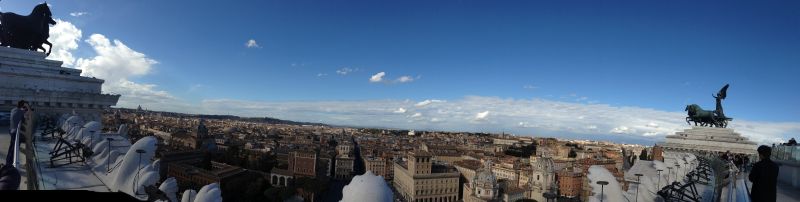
[{"left": 0, "top": 47, "right": 120, "bottom": 121}]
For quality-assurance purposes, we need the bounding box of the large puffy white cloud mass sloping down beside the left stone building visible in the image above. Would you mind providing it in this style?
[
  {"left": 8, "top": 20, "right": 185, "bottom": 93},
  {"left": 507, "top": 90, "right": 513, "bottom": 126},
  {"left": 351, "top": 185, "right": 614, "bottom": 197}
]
[{"left": 48, "top": 19, "right": 188, "bottom": 111}]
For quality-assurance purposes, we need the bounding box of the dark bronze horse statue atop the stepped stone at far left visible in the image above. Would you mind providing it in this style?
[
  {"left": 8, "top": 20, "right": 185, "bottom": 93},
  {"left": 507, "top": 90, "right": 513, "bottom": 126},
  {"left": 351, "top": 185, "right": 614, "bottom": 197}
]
[{"left": 0, "top": 3, "right": 56, "bottom": 55}]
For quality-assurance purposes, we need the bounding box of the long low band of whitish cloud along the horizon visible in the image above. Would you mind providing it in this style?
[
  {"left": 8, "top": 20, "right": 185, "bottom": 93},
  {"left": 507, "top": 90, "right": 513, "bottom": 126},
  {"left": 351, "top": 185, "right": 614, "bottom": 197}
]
[{"left": 199, "top": 96, "right": 800, "bottom": 143}]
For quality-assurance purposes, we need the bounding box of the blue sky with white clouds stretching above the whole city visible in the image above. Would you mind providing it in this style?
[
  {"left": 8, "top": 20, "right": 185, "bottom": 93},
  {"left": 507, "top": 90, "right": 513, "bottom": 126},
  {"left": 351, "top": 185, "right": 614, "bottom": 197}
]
[{"left": 0, "top": 0, "right": 800, "bottom": 144}]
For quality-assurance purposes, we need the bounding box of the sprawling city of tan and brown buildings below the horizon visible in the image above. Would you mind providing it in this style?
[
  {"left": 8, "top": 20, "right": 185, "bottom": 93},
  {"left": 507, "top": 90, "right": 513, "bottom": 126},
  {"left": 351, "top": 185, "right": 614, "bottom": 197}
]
[{"left": 105, "top": 106, "right": 680, "bottom": 202}]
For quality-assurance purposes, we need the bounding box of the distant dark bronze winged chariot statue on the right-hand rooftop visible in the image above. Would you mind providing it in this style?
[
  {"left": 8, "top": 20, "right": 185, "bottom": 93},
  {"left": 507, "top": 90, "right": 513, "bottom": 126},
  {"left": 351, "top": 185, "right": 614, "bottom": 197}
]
[{"left": 685, "top": 84, "right": 733, "bottom": 128}]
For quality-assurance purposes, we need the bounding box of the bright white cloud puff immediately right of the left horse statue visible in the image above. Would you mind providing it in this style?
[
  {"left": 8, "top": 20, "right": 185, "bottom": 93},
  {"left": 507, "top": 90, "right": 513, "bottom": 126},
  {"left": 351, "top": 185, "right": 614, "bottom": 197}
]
[{"left": 47, "top": 19, "right": 83, "bottom": 67}]
